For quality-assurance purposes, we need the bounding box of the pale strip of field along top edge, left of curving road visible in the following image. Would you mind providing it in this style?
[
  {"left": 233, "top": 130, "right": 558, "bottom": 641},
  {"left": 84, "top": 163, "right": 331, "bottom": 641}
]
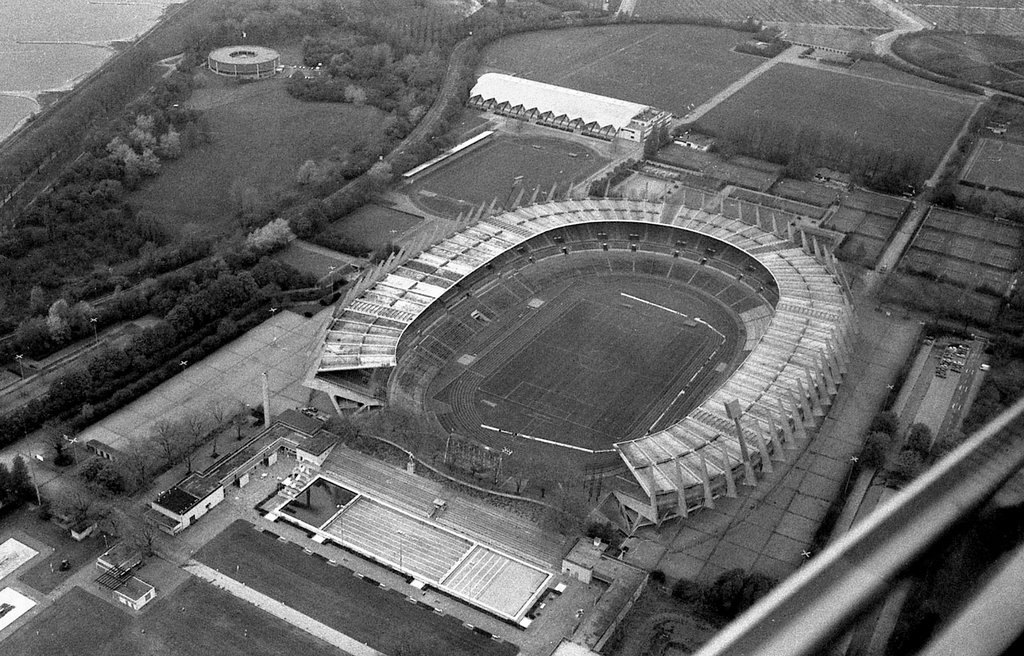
[{"left": 633, "top": 0, "right": 895, "bottom": 30}]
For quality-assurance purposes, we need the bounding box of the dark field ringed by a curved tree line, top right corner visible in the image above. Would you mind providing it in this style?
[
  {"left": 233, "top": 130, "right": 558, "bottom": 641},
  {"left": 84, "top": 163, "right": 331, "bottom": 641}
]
[{"left": 893, "top": 32, "right": 1024, "bottom": 93}]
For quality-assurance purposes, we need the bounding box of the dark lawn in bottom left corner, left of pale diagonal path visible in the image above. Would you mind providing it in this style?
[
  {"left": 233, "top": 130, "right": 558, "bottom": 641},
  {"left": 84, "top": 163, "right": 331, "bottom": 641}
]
[{"left": 0, "top": 579, "right": 338, "bottom": 656}]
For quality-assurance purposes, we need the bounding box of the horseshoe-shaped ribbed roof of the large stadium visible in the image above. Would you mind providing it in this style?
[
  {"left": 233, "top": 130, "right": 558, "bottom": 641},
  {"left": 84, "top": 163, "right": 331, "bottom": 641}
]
[{"left": 309, "top": 200, "right": 852, "bottom": 507}]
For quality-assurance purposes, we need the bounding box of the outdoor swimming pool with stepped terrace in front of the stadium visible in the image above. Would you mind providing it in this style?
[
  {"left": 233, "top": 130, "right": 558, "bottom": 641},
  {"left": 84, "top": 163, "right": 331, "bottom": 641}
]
[{"left": 268, "top": 438, "right": 561, "bottom": 623}]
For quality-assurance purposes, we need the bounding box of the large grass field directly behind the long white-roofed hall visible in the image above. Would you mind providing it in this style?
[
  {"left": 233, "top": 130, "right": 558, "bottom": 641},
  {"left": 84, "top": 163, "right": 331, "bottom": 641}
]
[{"left": 483, "top": 25, "right": 764, "bottom": 116}]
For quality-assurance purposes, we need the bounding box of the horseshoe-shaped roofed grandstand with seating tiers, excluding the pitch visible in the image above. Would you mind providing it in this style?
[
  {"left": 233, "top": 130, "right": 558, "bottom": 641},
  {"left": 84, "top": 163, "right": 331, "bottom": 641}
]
[{"left": 308, "top": 200, "right": 853, "bottom": 526}]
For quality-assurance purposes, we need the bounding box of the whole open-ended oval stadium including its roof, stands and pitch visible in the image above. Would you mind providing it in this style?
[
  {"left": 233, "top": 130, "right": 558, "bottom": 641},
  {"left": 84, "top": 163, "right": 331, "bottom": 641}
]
[{"left": 307, "top": 200, "right": 853, "bottom": 528}]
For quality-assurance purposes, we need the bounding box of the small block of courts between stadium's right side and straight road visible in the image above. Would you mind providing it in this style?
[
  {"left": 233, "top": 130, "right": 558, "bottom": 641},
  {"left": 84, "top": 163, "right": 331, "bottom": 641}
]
[{"left": 825, "top": 190, "right": 910, "bottom": 266}]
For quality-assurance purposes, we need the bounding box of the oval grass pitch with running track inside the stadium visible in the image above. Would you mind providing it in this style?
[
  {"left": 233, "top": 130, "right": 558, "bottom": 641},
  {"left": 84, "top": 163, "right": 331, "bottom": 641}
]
[{"left": 434, "top": 266, "right": 738, "bottom": 451}]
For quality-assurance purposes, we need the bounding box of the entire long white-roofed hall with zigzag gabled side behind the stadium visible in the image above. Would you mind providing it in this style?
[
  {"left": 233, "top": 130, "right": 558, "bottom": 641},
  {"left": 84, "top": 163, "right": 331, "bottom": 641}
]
[{"left": 469, "top": 73, "right": 672, "bottom": 141}]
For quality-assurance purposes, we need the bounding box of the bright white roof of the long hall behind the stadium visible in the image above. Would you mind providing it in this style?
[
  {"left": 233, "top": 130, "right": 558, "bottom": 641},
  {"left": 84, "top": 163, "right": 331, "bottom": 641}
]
[{"left": 469, "top": 73, "right": 648, "bottom": 129}]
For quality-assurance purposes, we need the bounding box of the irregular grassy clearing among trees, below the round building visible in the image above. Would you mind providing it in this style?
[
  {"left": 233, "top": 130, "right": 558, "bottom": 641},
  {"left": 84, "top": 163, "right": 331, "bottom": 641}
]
[{"left": 130, "top": 74, "right": 382, "bottom": 239}]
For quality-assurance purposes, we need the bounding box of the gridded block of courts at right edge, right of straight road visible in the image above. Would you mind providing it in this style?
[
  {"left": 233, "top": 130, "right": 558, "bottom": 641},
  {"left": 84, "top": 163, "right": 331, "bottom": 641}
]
[{"left": 901, "top": 208, "right": 1024, "bottom": 296}]
